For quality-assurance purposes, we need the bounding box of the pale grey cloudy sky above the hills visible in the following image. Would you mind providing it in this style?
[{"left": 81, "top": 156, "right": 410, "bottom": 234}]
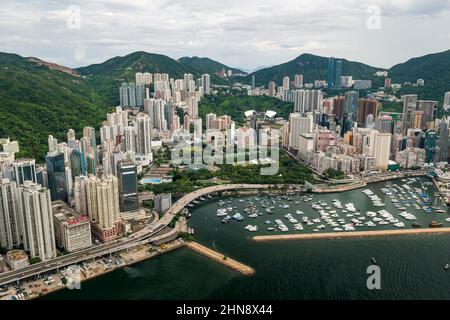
[{"left": 0, "top": 0, "right": 450, "bottom": 69}]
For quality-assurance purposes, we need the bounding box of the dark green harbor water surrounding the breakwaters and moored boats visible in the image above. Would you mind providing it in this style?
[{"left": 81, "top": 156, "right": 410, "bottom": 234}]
[{"left": 43, "top": 178, "right": 450, "bottom": 299}]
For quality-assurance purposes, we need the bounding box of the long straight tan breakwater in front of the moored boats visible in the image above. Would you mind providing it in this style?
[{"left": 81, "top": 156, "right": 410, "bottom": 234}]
[{"left": 252, "top": 227, "right": 450, "bottom": 242}]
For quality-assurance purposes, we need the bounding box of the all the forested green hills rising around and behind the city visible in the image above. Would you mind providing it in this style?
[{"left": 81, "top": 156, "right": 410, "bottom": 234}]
[{"left": 0, "top": 51, "right": 450, "bottom": 160}]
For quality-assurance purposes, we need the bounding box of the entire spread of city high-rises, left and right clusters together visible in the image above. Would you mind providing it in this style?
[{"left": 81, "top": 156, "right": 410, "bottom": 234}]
[{"left": 0, "top": 58, "right": 450, "bottom": 268}]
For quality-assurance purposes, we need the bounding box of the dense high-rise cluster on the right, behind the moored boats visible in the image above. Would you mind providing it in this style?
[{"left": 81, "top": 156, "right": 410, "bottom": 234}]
[{"left": 270, "top": 69, "right": 450, "bottom": 174}]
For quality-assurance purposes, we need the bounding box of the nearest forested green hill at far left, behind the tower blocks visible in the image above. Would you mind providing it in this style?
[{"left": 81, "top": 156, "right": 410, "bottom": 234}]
[{"left": 0, "top": 53, "right": 109, "bottom": 160}]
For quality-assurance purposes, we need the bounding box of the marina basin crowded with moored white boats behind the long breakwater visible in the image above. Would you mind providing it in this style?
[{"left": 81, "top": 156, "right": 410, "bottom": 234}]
[{"left": 207, "top": 177, "right": 450, "bottom": 234}]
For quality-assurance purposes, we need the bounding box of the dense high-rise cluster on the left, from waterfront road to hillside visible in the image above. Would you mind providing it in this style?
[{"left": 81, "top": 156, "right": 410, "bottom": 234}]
[{"left": 0, "top": 73, "right": 214, "bottom": 266}]
